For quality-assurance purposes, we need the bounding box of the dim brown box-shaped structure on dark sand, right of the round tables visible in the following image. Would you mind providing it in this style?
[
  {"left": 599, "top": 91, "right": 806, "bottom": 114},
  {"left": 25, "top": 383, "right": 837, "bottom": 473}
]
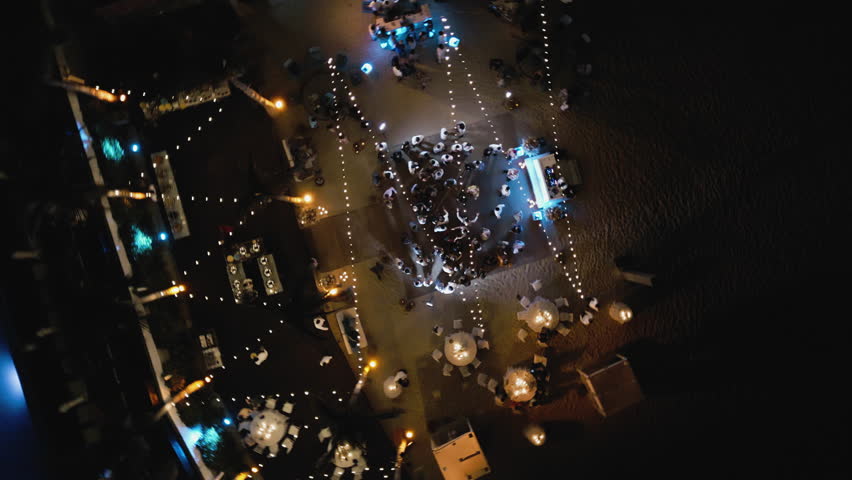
[{"left": 578, "top": 355, "right": 643, "bottom": 417}]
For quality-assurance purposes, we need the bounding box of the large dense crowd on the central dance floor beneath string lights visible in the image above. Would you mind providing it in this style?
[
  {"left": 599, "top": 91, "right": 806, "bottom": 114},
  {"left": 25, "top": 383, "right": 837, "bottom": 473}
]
[{"left": 374, "top": 121, "right": 525, "bottom": 294}]
